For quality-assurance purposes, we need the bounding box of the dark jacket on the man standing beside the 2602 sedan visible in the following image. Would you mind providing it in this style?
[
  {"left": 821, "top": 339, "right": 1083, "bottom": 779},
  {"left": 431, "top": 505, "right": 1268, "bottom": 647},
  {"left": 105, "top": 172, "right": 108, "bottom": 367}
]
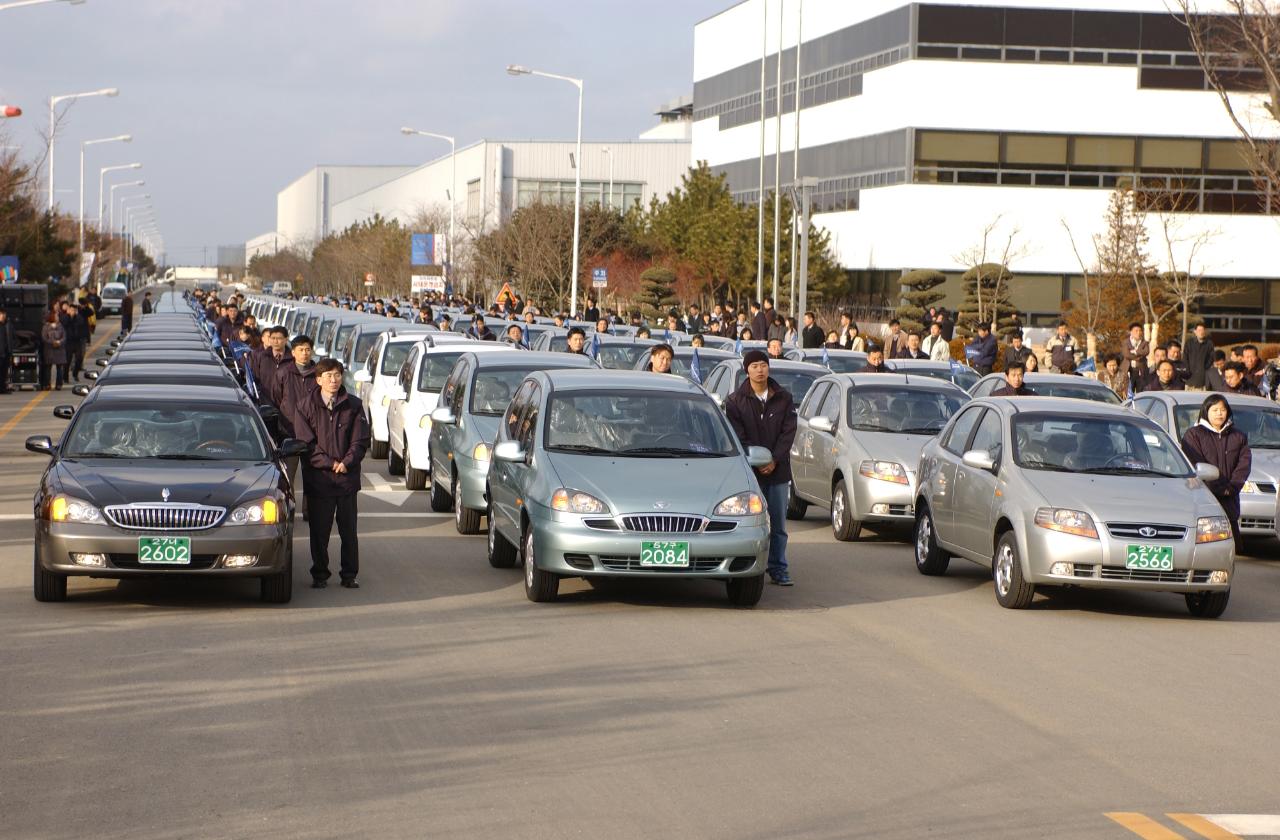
[{"left": 294, "top": 389, "right": 370, "bottom": 497}]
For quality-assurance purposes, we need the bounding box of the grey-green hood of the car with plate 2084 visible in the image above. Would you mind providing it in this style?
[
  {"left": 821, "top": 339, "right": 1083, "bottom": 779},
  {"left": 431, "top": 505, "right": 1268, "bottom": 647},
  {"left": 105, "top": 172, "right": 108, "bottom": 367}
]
[{"left": 548, "top": 452, "right": 759, "bottom": 516}]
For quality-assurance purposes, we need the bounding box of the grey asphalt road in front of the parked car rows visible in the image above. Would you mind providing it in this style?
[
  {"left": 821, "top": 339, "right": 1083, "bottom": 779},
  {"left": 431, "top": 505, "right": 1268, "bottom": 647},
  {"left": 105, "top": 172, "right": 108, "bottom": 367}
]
[{"left": 0, "top": 321, "right": 1280, "bottom": 840}]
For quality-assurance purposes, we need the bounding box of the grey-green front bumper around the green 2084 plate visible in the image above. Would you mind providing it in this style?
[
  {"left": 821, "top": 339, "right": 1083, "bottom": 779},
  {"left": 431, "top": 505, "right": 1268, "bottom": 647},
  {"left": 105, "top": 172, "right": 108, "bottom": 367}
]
[{"left": 532, "top": 512, "right": 769, "bottom": 580}]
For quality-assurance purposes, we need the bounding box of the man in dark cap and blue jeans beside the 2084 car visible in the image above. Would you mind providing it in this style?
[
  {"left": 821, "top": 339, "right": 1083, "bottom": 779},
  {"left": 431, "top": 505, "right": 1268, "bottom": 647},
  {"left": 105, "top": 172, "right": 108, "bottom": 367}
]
[{"left": 724, "top": 350, "right": 796, "bottom": 586}]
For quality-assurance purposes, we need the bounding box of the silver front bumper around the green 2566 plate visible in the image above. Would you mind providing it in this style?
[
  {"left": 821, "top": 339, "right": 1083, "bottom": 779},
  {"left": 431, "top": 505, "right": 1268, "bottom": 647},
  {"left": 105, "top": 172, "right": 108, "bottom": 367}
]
[{"left": 1024, "top": 525, "right": 1235, "bottom": 592}]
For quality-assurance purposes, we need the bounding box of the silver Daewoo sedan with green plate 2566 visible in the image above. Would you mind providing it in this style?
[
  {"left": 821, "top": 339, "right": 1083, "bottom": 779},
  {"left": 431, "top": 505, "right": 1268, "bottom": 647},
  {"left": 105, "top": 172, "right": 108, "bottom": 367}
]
[{"left": 915, "top": 397, "right": 1235, "bottom": 617}]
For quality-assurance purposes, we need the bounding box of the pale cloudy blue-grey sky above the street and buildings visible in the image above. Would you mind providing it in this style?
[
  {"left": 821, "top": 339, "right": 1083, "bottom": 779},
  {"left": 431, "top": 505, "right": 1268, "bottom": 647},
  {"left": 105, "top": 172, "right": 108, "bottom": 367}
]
[{"left": 0, "top": 0, "right": 732, "bottom": 264}]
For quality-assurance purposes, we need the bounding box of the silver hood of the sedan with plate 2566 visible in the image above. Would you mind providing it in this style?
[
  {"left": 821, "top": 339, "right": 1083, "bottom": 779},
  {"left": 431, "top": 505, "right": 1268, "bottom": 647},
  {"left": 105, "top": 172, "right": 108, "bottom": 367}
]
[{"left": 1023, "top": 470, "right": 1222, "bottom": 528}]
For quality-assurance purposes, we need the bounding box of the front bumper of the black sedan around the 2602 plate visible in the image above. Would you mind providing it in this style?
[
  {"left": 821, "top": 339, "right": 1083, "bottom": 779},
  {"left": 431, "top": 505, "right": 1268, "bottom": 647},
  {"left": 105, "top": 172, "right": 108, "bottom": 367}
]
[{"left": 36, "top": 520, "right": 293, "bottom": 578}]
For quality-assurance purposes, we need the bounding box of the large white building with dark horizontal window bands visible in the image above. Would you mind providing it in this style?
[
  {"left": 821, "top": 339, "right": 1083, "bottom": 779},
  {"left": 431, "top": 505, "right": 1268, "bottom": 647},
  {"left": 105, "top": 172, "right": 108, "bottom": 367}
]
[{"left": 692, "top": 0, "right": 1280, "bottom": 330}]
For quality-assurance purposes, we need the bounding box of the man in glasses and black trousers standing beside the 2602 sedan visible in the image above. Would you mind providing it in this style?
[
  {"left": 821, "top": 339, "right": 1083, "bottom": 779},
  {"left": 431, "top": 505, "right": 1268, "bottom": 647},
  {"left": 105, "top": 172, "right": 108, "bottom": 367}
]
[{"left": 296, "top": 359, "right": 369, "bottom": 589}]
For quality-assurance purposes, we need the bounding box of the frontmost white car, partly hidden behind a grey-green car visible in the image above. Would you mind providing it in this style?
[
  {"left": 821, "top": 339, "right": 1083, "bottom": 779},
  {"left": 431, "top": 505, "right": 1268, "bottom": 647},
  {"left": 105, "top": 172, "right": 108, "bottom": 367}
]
[{"left": 387, "top": 333, "right": 524, "bottom": 490}]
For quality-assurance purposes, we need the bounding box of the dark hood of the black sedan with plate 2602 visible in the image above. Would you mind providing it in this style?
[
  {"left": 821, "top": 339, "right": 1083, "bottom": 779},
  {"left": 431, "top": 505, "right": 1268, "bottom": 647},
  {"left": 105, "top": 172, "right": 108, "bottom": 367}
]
[{"left": 50, "top": 460, "right": 279, "bottom": 507}]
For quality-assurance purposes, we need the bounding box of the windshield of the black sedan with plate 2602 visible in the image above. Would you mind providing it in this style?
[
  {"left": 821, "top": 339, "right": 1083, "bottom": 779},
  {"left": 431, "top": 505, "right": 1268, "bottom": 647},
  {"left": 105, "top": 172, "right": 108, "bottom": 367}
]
[{"left": 61, "top": 406, "right": 269, "bottom": 461}]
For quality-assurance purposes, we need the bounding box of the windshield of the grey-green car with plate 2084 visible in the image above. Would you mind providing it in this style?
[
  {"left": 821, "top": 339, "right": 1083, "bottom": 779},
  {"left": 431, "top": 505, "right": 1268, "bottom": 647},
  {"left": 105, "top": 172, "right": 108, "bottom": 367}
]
[{"left": 545, "top": 389, "right": 739, "bottom": 458}]
